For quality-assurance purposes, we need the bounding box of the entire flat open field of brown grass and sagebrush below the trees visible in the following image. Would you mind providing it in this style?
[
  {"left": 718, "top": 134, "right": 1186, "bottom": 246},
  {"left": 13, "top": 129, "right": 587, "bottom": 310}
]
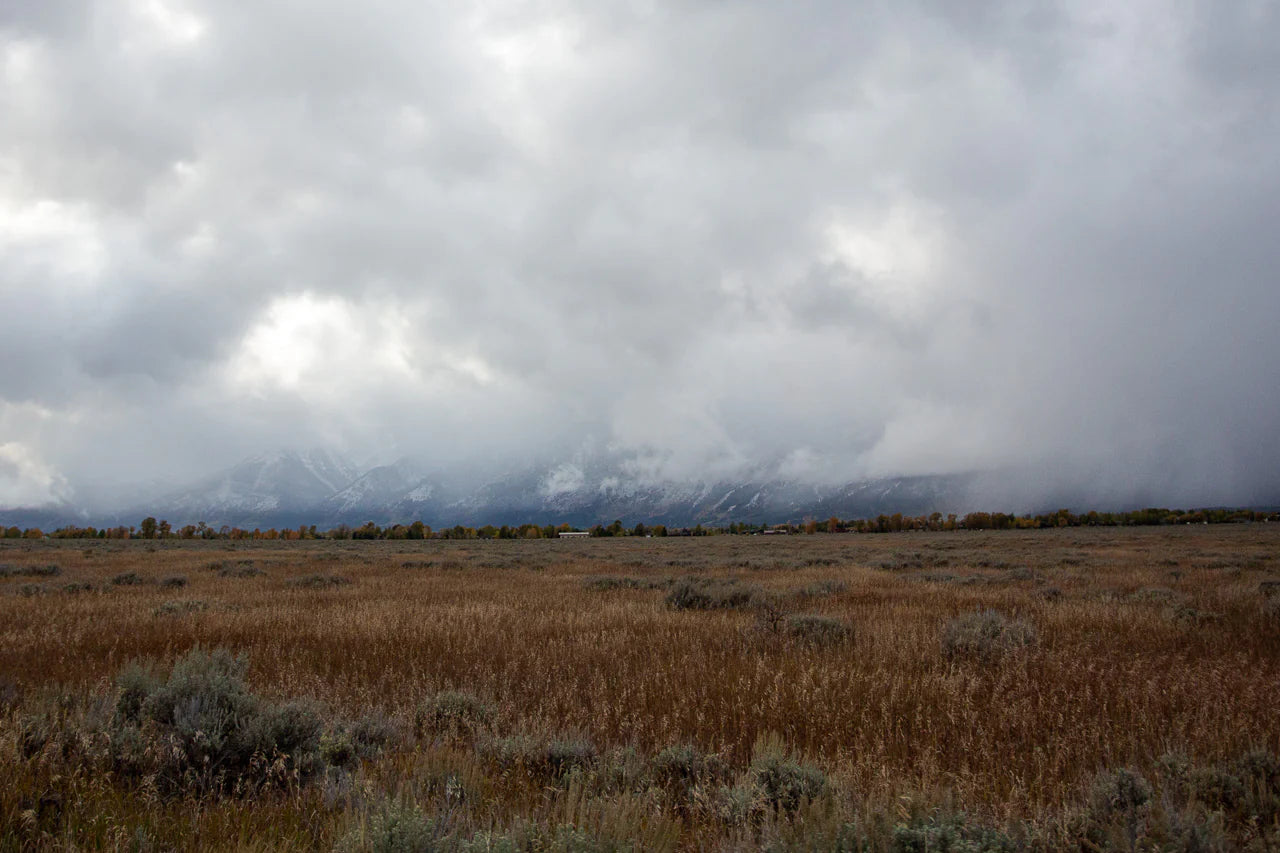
[{"left": 0, "top": 524, "right": 1280, "bottom": 850}]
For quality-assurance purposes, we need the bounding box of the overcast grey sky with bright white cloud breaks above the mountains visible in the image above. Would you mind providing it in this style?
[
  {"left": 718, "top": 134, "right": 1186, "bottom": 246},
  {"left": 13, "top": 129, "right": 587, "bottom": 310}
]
[{"left": 0, "top": 0, "right": 1280, "bottom": 506}]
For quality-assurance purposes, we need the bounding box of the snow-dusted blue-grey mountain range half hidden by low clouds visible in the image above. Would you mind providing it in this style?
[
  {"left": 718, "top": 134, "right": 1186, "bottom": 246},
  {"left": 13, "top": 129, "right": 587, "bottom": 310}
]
[{"left": 0, "top": 450, "right": 973, "bottom": 529}]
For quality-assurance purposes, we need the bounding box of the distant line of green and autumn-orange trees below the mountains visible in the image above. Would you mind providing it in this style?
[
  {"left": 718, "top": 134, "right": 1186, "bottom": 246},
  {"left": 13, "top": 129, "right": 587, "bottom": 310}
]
[{"left": 0, "top": 507, "right": 1280, "bottom": 540}]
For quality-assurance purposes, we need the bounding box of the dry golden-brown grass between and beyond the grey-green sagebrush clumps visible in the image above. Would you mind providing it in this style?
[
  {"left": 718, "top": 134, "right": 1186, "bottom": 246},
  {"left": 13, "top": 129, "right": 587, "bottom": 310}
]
[{"left": 0, "top": 524, "right": 1280, "bottom": 849}]
